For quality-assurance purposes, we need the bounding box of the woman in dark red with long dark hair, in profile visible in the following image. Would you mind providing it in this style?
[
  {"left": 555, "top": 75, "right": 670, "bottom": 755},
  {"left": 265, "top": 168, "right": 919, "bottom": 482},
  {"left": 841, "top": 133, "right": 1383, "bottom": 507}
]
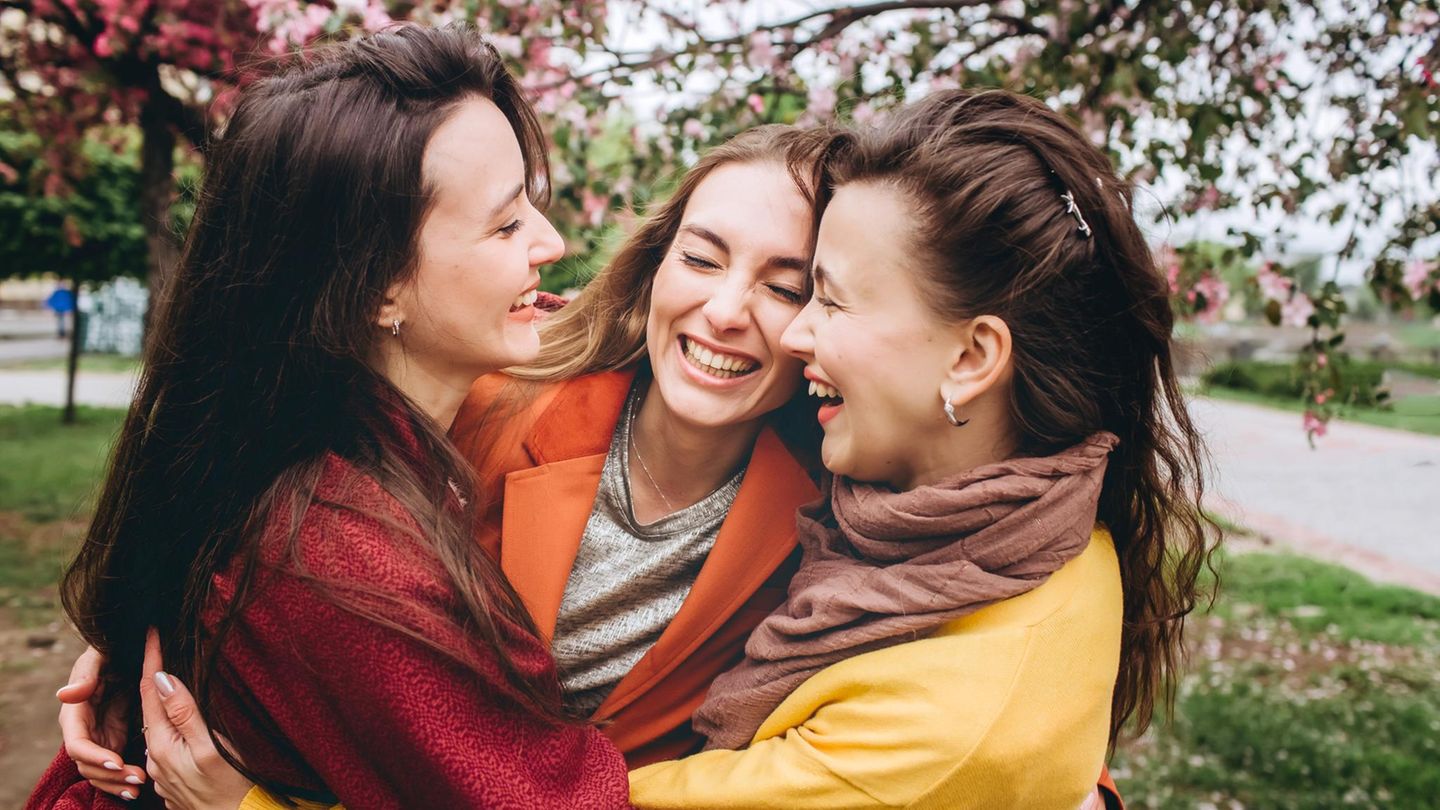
[{"left": 29, "top": 27, "right": 626, "bottom": 809}]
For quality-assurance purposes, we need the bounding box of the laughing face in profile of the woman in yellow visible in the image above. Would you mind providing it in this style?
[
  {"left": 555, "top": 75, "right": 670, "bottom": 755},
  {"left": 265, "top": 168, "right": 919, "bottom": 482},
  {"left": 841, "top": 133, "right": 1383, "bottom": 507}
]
[{"left": 783, "top": 184, "right": 956, "bottom": 489}]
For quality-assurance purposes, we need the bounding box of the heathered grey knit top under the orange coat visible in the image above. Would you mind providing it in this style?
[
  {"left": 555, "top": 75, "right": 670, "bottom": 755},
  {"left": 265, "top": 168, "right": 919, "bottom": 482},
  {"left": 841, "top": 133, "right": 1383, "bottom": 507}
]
[{"left": 552, "top": 386, "right": 744, "bottom": 715}]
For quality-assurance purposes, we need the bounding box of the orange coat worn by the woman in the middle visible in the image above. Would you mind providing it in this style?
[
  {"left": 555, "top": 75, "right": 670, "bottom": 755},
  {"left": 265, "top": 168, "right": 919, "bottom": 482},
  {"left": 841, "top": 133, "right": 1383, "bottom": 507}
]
[{"left": 451, "top": 369, "right": 819, "bottom": 768}]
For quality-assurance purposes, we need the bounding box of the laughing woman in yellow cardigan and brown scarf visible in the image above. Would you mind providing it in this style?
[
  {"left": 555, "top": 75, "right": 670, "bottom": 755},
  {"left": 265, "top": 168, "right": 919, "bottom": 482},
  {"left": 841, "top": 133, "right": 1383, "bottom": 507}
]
[{"left": 619, "top": 91, "right": 1212, "bottom": 810}]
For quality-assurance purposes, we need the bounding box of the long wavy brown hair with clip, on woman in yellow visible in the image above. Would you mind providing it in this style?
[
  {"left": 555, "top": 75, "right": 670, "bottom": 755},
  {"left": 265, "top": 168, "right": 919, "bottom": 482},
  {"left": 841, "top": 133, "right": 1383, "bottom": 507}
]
[{"left": 828, "top": 91, "right": 1218, "bottom": 744}]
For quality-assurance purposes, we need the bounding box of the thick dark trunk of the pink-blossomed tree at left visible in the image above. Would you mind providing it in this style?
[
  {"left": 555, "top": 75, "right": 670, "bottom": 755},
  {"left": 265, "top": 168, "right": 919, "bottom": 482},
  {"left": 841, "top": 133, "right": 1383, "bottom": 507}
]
[{"left": 140, "top": 72, "right": 180, "bottom": 348}]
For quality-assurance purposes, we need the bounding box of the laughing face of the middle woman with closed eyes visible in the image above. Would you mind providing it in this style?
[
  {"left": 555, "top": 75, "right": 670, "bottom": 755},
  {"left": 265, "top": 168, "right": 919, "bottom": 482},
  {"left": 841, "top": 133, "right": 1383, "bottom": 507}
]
[{"left": 645, "top": 163, "right": 812, "bottom": 427}]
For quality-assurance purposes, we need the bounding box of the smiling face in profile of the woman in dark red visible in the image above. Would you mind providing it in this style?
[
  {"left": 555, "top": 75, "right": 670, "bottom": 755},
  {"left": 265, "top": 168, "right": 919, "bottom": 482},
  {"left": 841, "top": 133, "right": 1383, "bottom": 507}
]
[{"left": 380, "top": 98, "right": 564, "bottom": 379}]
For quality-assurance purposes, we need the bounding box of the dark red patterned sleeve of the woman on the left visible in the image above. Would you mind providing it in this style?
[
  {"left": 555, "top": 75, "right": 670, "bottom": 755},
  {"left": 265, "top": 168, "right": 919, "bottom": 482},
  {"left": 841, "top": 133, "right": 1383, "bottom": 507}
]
[{"left": 210, "top": 507, "right": 625, "bottom": 807}]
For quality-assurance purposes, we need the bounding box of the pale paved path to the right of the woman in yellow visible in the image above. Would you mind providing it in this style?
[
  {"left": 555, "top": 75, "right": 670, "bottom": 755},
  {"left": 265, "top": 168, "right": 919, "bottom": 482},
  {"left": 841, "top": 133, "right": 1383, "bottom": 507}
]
[{"left": 1191, "top": 399, "right": 1440, "bottom": 594}]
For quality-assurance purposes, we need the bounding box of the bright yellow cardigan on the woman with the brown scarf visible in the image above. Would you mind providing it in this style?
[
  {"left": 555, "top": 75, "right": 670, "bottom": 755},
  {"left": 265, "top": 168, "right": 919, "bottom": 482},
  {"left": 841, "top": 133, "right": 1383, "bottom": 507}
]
[{"left": 240, "top": 528, "right": 1122, "bottom": 810}]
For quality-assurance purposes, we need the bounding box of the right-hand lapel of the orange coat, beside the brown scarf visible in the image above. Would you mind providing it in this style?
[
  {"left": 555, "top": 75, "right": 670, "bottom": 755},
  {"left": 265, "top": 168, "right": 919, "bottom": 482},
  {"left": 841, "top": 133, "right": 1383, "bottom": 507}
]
[{"left": 593, "top": 428, "right": 819, "bottom": 719}]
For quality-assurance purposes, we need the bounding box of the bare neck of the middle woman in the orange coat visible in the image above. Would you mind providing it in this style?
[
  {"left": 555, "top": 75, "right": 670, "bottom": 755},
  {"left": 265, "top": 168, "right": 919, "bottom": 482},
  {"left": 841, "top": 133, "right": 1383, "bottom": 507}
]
[{"left": 631, "top": 380, "right": 763, "bottom": 509}]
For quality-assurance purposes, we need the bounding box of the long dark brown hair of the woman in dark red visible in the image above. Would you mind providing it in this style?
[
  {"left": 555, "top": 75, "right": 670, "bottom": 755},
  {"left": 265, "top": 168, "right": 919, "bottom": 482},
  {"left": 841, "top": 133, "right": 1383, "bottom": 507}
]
[{"left": 62, "top": 26, "right": 563, "bottom": 778}]
